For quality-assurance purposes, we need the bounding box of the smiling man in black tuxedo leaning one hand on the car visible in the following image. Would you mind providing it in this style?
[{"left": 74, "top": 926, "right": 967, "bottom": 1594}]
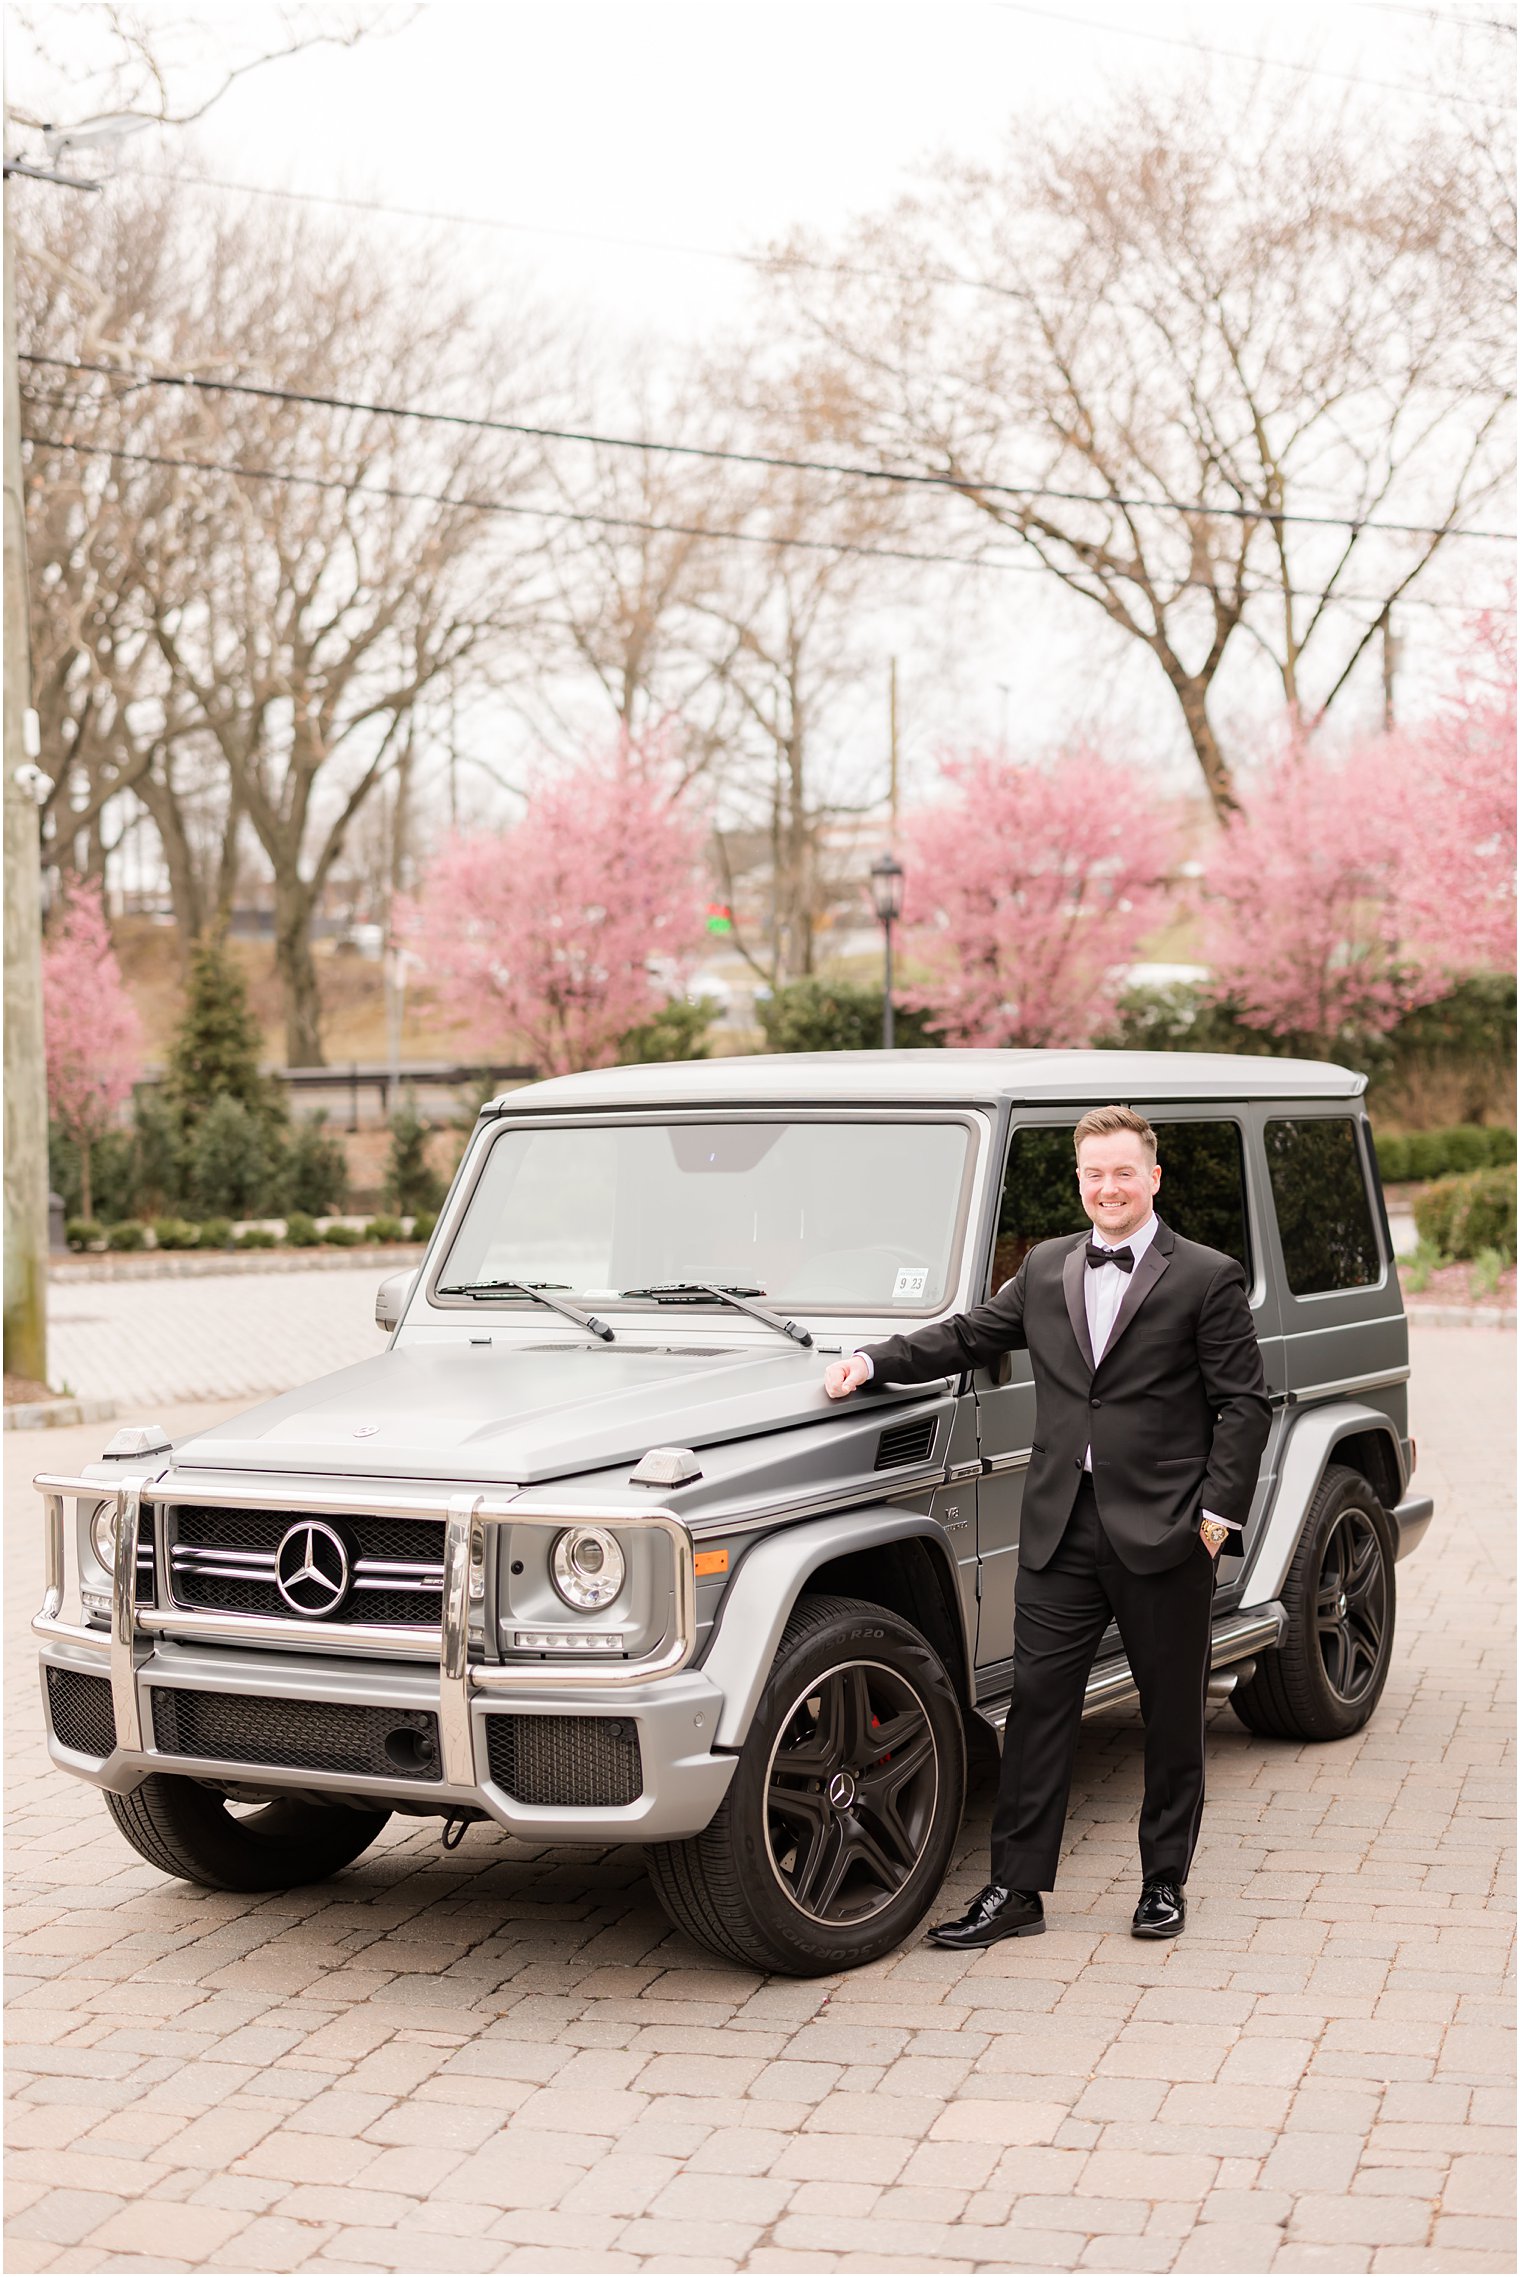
[{"left": 824, "top": 1107, "right": 1272, "bottom": 1949}]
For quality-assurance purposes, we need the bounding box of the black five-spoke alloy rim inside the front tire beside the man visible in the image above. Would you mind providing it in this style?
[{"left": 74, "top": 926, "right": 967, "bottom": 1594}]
[{"left": 765, "top": 1660, "right": 940, "bottom": 1924}]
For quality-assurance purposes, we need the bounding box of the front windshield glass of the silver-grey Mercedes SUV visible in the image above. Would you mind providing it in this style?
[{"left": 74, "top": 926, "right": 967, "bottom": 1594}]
[{"left": 437, "top": 1116, "right": 972, "bottom": 1314}]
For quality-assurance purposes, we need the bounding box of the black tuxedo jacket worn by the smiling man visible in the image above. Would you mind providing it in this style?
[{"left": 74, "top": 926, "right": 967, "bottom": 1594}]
[{"left": 865, "top": 1220, "right": 1272, "bottom": 1573}]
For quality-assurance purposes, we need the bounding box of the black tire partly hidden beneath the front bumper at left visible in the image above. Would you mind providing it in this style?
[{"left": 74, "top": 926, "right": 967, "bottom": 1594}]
[{"left": 105, "top": 1774, "right": 389, "bottom": 1892}]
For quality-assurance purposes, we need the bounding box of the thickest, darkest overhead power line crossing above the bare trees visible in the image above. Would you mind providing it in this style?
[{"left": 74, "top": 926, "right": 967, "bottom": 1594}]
[{"left": 20, "top": 351, "right": 1513, "bottom": 544}]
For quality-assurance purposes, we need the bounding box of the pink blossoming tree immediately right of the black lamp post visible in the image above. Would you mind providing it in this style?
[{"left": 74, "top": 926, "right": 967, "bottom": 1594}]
[{"left": 903, "top": 749, "right": 1179, "bottom": 1045}]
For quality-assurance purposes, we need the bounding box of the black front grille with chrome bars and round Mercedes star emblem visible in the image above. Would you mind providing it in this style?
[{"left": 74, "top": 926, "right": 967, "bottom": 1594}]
[{"left": 166, "top": 1503, "right": 444, "bottom": 1628}]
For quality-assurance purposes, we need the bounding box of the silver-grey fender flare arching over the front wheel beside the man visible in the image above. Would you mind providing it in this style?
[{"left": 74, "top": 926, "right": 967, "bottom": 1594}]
[{"left": 701, "top": 1510, "right": 974, "bottom": 1749}]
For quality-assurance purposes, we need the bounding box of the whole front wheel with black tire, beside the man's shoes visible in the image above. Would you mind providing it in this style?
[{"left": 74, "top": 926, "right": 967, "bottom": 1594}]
[{"left": 646, "top": 1596, "right": 965, "bottom": 1976}]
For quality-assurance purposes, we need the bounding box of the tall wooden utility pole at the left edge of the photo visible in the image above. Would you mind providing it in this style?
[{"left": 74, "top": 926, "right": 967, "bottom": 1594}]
[{"left": 5, "top": 204, "right": 48, "bottom": 1384}]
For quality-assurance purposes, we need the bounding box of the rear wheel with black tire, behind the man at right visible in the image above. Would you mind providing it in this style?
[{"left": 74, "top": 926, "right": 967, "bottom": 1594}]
[{"left": 1229, "top": 1464, "right": 1395, "bottom": 1740}]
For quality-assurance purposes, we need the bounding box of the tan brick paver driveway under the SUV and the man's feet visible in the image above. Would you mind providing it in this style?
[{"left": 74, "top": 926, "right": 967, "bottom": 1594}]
[{"left": 7, "top": 1330, "right": 1515, "bottom": 2272}]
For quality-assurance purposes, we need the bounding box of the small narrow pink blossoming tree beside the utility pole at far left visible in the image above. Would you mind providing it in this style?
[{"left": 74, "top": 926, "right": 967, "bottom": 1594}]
[{"left": 43, "top": 881, "right": 143, "bottom": 1218}]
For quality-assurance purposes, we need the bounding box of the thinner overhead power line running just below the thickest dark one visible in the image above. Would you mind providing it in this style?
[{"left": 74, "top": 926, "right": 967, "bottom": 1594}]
[{"left": 25, "top": 435, "right": 1502, "bottom": 613}]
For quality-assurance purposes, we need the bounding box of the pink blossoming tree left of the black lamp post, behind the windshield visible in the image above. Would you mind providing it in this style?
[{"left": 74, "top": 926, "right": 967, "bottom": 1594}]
[{"left": 398, "top": 742, "right": 703, "bottom": 1075}]
